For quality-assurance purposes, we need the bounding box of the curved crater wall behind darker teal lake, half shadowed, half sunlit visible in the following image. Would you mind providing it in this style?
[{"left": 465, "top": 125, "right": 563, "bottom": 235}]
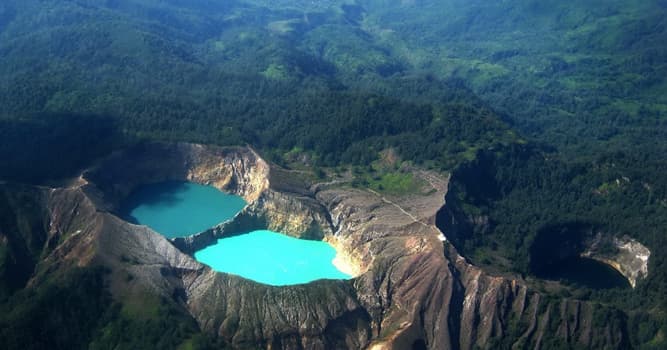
[{"left": 82, "top": 143, "right": 269, "bottom": 211}]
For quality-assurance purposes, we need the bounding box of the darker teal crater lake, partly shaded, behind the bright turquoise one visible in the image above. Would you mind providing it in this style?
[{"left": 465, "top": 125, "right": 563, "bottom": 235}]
[{"left": 121, "top": 182, "right": 246, "bottom": 238}]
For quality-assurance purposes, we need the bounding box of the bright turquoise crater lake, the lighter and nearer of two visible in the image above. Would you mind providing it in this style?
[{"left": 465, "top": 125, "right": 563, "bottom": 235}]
[{"left": 195, "top": 230, "right": 352, "bottom": 286}]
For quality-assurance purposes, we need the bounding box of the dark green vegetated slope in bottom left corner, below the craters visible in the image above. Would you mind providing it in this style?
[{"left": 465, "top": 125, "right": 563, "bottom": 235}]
[{"left": 0, "top": 267, "right": 225, "bottom": 349}]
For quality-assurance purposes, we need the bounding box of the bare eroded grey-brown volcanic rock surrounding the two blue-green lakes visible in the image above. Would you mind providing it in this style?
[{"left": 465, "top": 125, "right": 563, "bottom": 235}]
[{"left": 14, "top": 144, "right": 627, "bottom": 349}]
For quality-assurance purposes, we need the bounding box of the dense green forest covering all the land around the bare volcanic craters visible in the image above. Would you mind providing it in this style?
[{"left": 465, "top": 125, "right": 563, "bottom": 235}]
[{"left": 0, "top": 0, "right": 667, "bottom": 349}]
